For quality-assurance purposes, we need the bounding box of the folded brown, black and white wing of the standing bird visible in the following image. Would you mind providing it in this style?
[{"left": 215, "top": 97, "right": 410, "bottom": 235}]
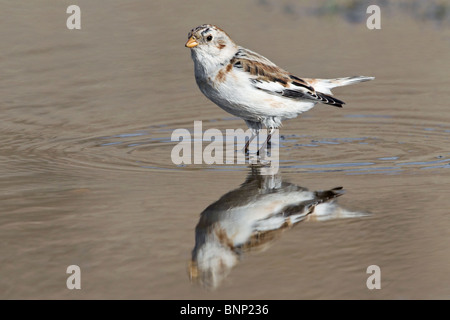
[{"left": 230, "top": 48, "right": 344, "bottom": 107}]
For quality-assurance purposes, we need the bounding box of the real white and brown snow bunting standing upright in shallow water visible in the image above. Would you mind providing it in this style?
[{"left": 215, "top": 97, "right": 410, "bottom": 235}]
[{"left": 185, "top": 24, "right": 374, "bottom": 149}]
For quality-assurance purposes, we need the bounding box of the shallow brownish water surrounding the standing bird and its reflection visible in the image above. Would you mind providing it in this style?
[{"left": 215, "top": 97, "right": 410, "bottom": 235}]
[{"left": 0, "top": 1, "right": 450, "bottom": 299}]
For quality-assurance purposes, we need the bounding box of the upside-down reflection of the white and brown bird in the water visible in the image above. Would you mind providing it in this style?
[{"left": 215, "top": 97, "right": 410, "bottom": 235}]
[{"left": 189, "top": 167, "right": 365, "bottom": 289}]
